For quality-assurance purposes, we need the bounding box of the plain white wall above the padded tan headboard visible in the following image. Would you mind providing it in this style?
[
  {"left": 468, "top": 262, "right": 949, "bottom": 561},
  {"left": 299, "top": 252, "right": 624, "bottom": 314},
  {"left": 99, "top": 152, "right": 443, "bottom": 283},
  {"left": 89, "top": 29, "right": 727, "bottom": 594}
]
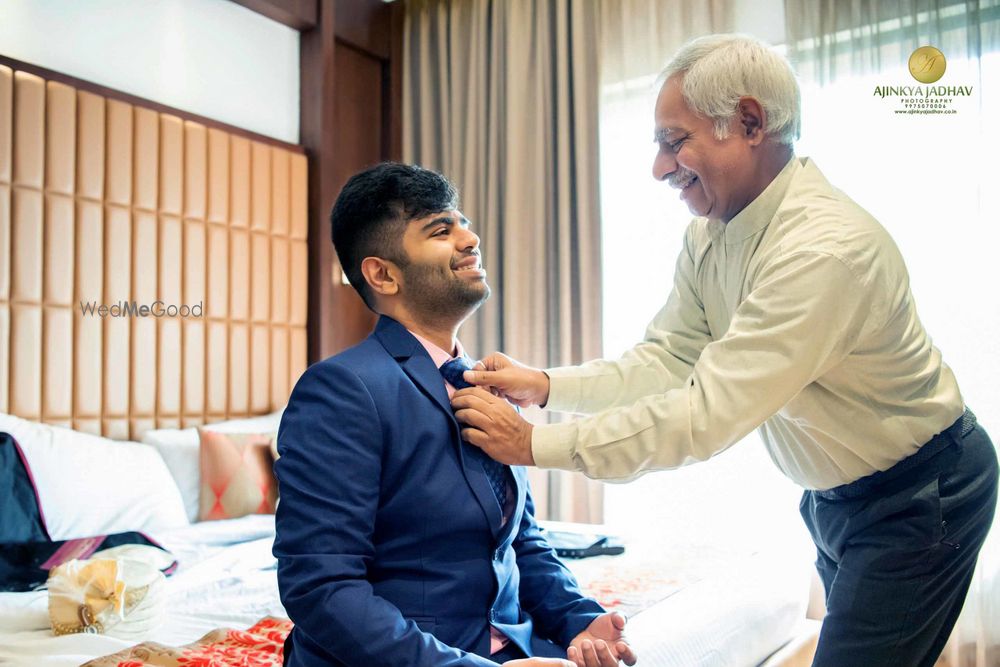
[{"left": 0, "top": 0, "right": 299, "bottom": 143}]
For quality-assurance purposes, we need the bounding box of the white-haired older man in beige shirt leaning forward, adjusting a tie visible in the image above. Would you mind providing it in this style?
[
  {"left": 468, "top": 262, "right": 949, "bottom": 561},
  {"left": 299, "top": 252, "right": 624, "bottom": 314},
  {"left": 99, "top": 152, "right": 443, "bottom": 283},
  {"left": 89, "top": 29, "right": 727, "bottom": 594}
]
[{"left": 452, "top": 35, "right": 997, "bottom": 667}]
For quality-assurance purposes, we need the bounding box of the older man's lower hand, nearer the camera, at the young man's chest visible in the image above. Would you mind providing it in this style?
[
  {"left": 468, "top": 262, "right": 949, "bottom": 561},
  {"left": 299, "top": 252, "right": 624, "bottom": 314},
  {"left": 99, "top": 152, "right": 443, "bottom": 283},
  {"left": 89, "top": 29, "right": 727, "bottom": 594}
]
[{"left": 451, "top": 387, "right": 535, "bottom": 466}]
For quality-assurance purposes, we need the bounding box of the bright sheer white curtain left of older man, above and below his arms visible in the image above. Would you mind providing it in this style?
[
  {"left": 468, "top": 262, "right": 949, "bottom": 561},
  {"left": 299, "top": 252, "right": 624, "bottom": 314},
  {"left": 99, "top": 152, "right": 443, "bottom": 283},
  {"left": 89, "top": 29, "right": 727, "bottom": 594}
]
[{"left": 600, "top": 0, "right": 814, "bottom": 570}]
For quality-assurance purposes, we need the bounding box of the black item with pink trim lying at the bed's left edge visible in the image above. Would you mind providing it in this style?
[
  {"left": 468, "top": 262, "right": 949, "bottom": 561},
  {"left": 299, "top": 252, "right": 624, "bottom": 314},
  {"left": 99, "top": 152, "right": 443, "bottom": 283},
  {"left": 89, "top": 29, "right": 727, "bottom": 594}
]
[{"left": 0, "top": 432, "right": 177, "bottom": 592}]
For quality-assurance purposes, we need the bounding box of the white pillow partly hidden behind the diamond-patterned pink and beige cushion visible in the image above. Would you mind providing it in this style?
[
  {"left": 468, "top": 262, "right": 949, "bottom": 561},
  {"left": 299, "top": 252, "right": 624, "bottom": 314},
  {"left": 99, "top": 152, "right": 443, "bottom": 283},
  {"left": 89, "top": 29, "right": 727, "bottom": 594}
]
[{"left": 142, "top": 410, "right": 283, "bottom": 523}]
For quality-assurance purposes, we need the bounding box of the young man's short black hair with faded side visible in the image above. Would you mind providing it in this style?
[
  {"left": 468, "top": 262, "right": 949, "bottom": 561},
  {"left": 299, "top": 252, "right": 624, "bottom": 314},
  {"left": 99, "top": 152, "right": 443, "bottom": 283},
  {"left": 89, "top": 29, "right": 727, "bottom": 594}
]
[{"left": 330, "top": 162, "right": 458, "bottom": 311}]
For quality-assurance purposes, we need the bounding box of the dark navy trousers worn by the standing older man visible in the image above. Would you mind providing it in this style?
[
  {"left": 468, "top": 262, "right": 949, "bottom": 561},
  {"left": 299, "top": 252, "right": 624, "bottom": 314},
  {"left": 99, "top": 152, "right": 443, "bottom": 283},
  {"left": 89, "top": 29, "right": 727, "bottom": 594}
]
[{"left": 799, "top": 412, "right": 998, "bottom": 667}]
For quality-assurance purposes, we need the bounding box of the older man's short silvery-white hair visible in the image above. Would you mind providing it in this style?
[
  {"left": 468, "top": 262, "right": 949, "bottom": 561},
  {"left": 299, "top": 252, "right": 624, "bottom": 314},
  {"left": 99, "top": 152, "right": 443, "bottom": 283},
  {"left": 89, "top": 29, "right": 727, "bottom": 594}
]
[{"left": 660, "top": 35, "right": 802, "bottom": 145}]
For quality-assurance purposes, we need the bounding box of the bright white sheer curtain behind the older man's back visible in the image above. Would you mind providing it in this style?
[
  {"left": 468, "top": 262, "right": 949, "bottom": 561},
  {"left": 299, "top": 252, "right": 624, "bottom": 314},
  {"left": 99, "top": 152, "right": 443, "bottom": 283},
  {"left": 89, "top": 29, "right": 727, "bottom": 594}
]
[{"left": 785, "top": 0, "right": 1000, "bottom": 667}]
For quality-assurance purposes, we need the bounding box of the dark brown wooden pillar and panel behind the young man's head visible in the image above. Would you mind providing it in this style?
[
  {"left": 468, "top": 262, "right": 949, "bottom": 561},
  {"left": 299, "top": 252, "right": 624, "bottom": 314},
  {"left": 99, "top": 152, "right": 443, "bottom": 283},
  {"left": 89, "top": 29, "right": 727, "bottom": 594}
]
[{"left": 300, "top": 0, "right": 403, "bottom": 362}]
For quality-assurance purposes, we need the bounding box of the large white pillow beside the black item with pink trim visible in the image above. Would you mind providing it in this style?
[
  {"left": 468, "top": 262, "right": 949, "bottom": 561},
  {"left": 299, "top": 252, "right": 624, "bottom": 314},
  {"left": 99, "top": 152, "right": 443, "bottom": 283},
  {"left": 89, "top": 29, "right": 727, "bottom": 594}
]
[{"left": 0, "top": 414, "right": 188, "bottom": 540}]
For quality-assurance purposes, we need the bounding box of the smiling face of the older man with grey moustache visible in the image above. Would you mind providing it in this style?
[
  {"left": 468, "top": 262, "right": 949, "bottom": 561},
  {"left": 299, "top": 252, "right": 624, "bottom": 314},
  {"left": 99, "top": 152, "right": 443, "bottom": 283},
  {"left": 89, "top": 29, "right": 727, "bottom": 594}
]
[{"left": 653, "top": 76, "right": 754, "bottom": 222}]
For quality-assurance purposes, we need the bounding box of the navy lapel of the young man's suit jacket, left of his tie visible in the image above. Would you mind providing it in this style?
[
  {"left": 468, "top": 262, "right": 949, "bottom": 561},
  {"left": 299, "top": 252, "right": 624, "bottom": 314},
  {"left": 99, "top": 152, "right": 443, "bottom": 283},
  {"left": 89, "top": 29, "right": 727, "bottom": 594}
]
[{"left": 375, "top": 315, "right": 502, "bottom": 540}]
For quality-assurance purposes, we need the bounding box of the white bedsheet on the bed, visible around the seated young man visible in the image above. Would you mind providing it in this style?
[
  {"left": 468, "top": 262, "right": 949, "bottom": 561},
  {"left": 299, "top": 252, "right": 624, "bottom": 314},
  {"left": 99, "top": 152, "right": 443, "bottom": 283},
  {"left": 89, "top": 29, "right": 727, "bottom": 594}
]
[{"left": 0, "top": 516, "right": 809, "bottom": 667}]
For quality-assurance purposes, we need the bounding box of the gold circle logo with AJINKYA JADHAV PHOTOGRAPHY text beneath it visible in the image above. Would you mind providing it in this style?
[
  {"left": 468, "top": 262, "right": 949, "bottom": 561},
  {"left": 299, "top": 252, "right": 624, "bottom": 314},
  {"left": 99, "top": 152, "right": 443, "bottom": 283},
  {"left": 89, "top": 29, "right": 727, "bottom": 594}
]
[{"left": 873, "top": 45, "right": 972, "bottom": 115}]
